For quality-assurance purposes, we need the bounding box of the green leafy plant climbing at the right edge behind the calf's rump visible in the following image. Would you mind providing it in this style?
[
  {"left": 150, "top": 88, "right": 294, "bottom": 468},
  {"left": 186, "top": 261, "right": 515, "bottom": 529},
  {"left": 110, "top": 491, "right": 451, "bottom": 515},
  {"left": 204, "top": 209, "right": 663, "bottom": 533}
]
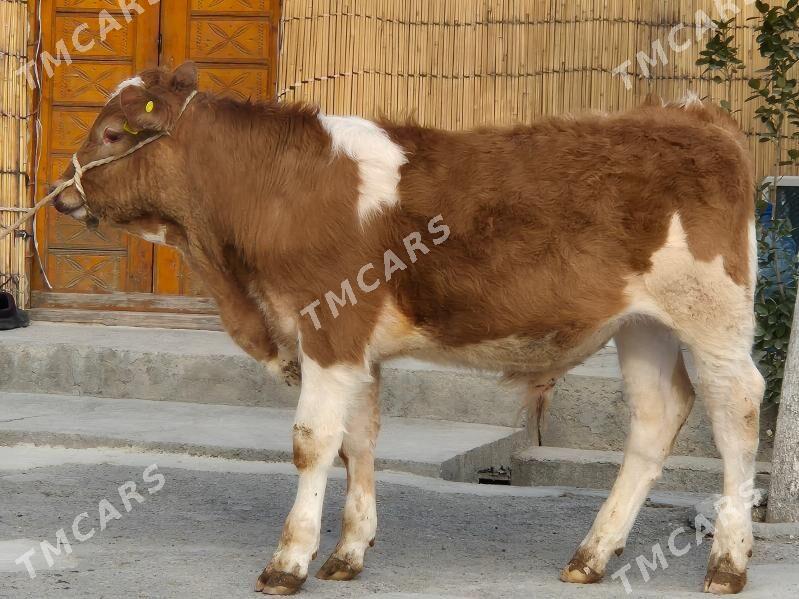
[{"left": 697, "top": 0, "right": 799, "bottom": 403}]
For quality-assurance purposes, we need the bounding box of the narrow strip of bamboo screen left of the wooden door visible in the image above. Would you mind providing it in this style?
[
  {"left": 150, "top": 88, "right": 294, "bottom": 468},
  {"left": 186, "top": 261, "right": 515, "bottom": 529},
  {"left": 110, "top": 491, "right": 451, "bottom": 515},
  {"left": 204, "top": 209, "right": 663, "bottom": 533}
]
[{"left": 0, "top": 0, "right": 30, "bottom": 305}]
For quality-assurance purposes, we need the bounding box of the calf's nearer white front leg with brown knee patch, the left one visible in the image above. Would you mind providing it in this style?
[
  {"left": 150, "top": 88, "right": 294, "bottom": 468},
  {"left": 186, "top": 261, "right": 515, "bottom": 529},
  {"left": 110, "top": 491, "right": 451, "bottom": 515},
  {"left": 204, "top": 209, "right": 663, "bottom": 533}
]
[{"left": 255, "top": 354, "right": 374, "bottom": 595}]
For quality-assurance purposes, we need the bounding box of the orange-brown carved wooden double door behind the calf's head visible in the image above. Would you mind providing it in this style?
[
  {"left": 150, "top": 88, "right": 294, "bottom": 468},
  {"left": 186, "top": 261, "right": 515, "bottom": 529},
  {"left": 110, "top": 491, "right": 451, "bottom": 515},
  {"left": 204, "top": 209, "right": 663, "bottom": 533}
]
[{"left": 32, "top": 0, "right": 279, "bottom": 326}]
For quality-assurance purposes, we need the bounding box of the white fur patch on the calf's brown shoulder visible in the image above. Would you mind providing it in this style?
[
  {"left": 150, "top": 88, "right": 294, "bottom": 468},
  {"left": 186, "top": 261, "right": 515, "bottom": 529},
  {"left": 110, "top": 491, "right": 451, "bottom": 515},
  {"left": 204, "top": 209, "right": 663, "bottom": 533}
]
[{"left": 319, "top": 114, "right": 408, "bottom": 222}]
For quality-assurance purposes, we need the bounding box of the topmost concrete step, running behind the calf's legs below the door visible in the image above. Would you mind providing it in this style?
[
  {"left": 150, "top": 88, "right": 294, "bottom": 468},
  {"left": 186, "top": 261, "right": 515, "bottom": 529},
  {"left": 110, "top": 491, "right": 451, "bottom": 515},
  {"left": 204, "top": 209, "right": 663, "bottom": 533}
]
[{"left": 0, "top": 323, "right": 776, "bottom": 460}]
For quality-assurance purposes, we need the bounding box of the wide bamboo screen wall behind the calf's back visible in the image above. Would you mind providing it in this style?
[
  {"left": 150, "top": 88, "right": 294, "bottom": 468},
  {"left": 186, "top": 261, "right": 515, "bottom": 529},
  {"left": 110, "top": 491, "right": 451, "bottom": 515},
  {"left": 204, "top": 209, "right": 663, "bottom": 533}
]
[{"left": 278, "top": 0, "right": 799, "bottom": 175}]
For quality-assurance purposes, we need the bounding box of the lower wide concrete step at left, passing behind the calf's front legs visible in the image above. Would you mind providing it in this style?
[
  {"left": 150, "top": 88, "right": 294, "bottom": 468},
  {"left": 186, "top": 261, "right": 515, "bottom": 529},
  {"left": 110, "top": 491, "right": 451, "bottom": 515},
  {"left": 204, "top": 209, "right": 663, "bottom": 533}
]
[{"left": 0, "top": 393, "right": 521, "bottom": 482}]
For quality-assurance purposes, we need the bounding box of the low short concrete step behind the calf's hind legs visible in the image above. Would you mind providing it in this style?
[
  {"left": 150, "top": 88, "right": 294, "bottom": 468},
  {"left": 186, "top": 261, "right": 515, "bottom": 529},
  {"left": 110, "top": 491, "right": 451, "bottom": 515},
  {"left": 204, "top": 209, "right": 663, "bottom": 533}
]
[{"left": 511, "top": 447, "right": 771, "bottom": 493}]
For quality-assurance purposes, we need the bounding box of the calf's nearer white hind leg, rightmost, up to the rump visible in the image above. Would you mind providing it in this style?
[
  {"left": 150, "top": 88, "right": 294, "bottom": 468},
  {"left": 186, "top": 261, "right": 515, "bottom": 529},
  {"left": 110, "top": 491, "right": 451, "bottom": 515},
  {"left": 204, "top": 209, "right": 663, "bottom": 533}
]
[{"left": 631, "top": 213, "right": 764, "bottom": 594}]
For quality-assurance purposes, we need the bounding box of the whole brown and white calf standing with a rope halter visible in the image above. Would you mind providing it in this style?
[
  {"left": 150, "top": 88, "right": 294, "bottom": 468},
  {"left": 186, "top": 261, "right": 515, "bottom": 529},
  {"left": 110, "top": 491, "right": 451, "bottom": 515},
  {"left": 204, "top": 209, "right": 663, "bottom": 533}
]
[{"left": 55, "top": 63, "right": 763, "bottom": 594}]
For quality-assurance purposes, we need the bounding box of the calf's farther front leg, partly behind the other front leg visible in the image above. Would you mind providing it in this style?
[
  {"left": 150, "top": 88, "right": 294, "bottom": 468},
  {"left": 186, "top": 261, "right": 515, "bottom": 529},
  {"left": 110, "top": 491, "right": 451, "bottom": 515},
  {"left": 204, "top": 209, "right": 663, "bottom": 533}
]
[{"left": 316, "top": 369, "right": 380, "bottom": 580}]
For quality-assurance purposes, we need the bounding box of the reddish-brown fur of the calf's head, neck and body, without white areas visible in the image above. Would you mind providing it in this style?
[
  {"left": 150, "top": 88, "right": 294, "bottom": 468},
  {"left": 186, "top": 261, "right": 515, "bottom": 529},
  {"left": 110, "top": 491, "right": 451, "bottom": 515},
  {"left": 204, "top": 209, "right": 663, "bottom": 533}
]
[{"left": 51, "top": 65, "right": 752, "bottom": 376}]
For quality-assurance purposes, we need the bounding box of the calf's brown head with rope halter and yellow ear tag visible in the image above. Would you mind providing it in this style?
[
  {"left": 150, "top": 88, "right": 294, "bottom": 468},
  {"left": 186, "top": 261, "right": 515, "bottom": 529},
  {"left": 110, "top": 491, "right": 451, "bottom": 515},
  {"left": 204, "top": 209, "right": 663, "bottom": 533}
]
[{"left": 53, "top": 63, "right": 197, "bottom": 239}]
